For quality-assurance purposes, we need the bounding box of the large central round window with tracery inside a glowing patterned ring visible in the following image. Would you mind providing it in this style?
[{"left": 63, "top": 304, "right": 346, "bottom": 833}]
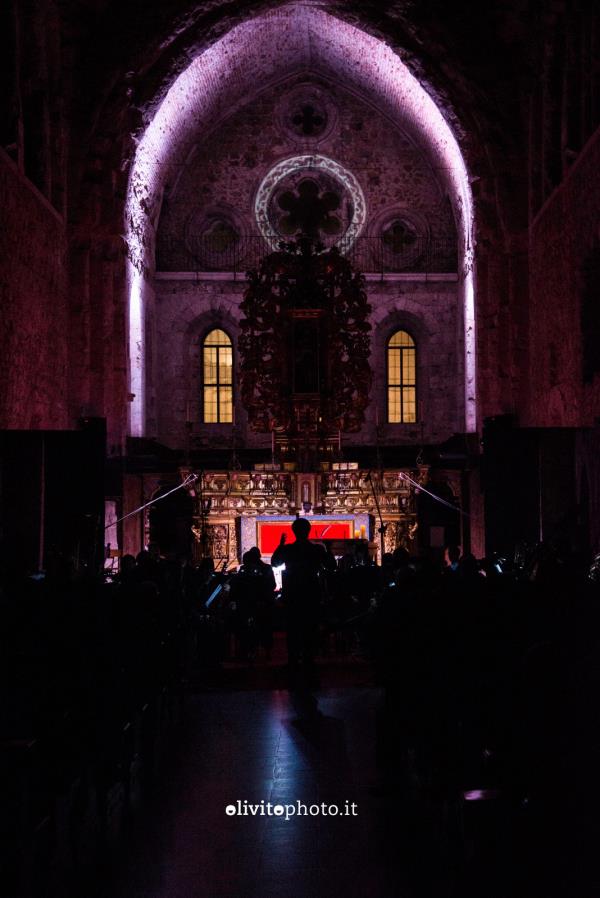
[{"left": 255, "top": 154, "right": 366, "bottom": 252}]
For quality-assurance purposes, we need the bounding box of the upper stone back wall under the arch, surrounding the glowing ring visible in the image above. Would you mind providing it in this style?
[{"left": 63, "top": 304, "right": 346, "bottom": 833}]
[{"left": 157, "top": 75, "right": 456, "bottom": 271}]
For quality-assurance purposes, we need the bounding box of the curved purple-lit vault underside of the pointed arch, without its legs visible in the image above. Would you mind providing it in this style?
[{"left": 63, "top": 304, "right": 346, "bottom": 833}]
[{"left": 129, "top": 3, "right": 471, "bottom": 266}]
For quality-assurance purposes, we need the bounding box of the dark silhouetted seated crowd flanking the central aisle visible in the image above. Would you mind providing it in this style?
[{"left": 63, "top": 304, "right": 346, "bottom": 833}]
[{"left": 0, "top": 519, "right": 600, "bottom": 896}]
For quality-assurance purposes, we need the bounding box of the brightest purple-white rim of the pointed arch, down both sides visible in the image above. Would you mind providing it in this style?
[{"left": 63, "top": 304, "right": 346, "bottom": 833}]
[{"left": 125, "top": 6, "right": 477, "bottom": 437}]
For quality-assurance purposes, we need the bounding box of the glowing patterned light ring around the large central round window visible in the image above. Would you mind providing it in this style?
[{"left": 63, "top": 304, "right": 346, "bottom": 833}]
[{"left": 254, "top": 153, "right": 367, "bottom": 252}]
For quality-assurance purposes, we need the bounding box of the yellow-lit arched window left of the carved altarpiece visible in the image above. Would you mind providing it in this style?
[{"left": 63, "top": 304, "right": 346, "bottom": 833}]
[{"left": 202, "top": 328, "right": 233, "bottom": 424}]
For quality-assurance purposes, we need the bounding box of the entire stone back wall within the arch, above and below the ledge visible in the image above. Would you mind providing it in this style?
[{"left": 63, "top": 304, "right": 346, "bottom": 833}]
[{"left": 152, "top": 68, "right": 464, "bottom": 456}]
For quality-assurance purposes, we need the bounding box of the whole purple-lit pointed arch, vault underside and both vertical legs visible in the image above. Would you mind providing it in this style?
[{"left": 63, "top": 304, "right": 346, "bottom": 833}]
[{"left": 126, "top": 4, "right": 477, "bottom": 436}]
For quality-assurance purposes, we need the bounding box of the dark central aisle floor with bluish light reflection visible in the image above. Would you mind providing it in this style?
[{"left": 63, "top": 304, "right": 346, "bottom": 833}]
[{"left": 106, "top": 688, "right": 410, "bottom": 898}]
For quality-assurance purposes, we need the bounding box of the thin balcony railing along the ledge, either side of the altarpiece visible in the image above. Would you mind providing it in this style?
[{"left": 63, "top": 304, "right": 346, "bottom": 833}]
[{"left": 156, "top": 235, "right": 458, "bottom": 275}]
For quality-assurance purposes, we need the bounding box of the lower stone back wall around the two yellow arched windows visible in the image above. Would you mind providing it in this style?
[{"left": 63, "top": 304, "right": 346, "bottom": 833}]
[{"left": 154, "top": 275, "right": 464, "bottom": 450}]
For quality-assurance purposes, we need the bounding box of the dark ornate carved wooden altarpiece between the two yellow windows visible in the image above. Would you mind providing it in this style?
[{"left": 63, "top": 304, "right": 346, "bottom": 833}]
[{"left": 238, "top": 236, "right": 372, "bottom": 456}]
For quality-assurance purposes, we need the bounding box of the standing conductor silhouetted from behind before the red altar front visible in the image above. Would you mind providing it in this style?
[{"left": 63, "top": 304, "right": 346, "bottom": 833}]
[{"left": 271, "top": 518, "right": 335, "bottom": 685}]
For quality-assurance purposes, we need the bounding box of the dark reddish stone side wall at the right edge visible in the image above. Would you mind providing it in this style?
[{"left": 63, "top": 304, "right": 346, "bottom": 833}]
[{"left": 524, "top": 125, "right": 600, "bottom": 427}]
